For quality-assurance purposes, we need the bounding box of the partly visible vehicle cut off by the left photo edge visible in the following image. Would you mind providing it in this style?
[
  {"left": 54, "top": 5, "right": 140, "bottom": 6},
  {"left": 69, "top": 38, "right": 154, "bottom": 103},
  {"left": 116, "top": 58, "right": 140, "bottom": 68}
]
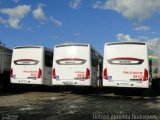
[{"left": 0, "top": 46, "right": 12, "bottom": 91}]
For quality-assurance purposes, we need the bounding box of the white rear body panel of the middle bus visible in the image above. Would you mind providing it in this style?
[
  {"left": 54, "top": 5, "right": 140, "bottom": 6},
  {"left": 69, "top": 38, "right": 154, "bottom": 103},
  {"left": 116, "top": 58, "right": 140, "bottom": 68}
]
[{"left": 53, "top": 46, "right": 91, "bottom": 86}]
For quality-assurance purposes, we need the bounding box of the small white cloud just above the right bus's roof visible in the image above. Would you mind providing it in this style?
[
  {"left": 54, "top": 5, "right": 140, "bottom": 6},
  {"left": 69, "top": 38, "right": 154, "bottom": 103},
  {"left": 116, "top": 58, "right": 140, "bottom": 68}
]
[{"left": 116, "top": 33, "right": 139, "bottom": 42}]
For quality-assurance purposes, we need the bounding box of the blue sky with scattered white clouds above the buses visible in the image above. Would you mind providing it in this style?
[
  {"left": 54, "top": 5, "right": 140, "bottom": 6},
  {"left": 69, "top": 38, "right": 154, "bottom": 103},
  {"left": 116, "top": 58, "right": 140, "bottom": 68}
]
[{"left": 0, "top": 0, "right": 160, "bottom": 53}]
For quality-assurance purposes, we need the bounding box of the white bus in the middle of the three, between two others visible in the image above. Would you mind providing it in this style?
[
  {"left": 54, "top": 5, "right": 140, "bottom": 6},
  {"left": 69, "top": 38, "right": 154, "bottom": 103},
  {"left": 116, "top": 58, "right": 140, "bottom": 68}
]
[{"left": 52, "top": 43, "right": 102, "bottom": 87}]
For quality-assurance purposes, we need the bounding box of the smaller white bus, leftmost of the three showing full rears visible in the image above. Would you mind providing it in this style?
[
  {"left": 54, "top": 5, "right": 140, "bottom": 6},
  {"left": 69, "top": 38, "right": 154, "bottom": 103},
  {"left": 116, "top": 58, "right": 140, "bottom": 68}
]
[{"left": 10, "top": 46, "right": 53, "bottom": 86}]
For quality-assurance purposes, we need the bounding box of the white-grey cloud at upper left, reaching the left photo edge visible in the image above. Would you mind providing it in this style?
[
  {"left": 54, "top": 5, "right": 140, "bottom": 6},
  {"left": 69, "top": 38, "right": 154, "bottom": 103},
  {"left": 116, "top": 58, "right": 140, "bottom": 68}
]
[{"left": 0, "top": 5, "right": 31, "bottom": 29}]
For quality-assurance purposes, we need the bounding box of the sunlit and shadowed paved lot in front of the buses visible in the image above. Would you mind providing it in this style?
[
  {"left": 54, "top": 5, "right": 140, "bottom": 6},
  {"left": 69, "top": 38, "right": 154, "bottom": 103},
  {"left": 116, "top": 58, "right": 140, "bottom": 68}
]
[{"left": 0, "top": 87, "right": 160, "bottom": 120}]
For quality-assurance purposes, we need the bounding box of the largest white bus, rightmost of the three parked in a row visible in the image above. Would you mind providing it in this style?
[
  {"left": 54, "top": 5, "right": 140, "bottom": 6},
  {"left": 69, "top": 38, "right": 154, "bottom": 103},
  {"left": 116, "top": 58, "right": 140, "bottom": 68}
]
[{"left": 103, "top": 42, "right": 156, "bottom": 88}]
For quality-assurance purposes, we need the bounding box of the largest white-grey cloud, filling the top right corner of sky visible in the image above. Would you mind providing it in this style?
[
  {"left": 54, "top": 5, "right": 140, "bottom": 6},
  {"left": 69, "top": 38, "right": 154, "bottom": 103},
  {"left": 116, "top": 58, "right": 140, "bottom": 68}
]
[{"left": 93, "top": 0, "right": 160, "bottom": 21}]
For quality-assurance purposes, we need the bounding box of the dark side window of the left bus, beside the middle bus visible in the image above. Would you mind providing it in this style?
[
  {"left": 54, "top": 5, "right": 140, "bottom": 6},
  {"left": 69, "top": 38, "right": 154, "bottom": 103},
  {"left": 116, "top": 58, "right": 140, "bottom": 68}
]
[{"left": 45, "top": 51, "right": 53, "bottom": 67}]
